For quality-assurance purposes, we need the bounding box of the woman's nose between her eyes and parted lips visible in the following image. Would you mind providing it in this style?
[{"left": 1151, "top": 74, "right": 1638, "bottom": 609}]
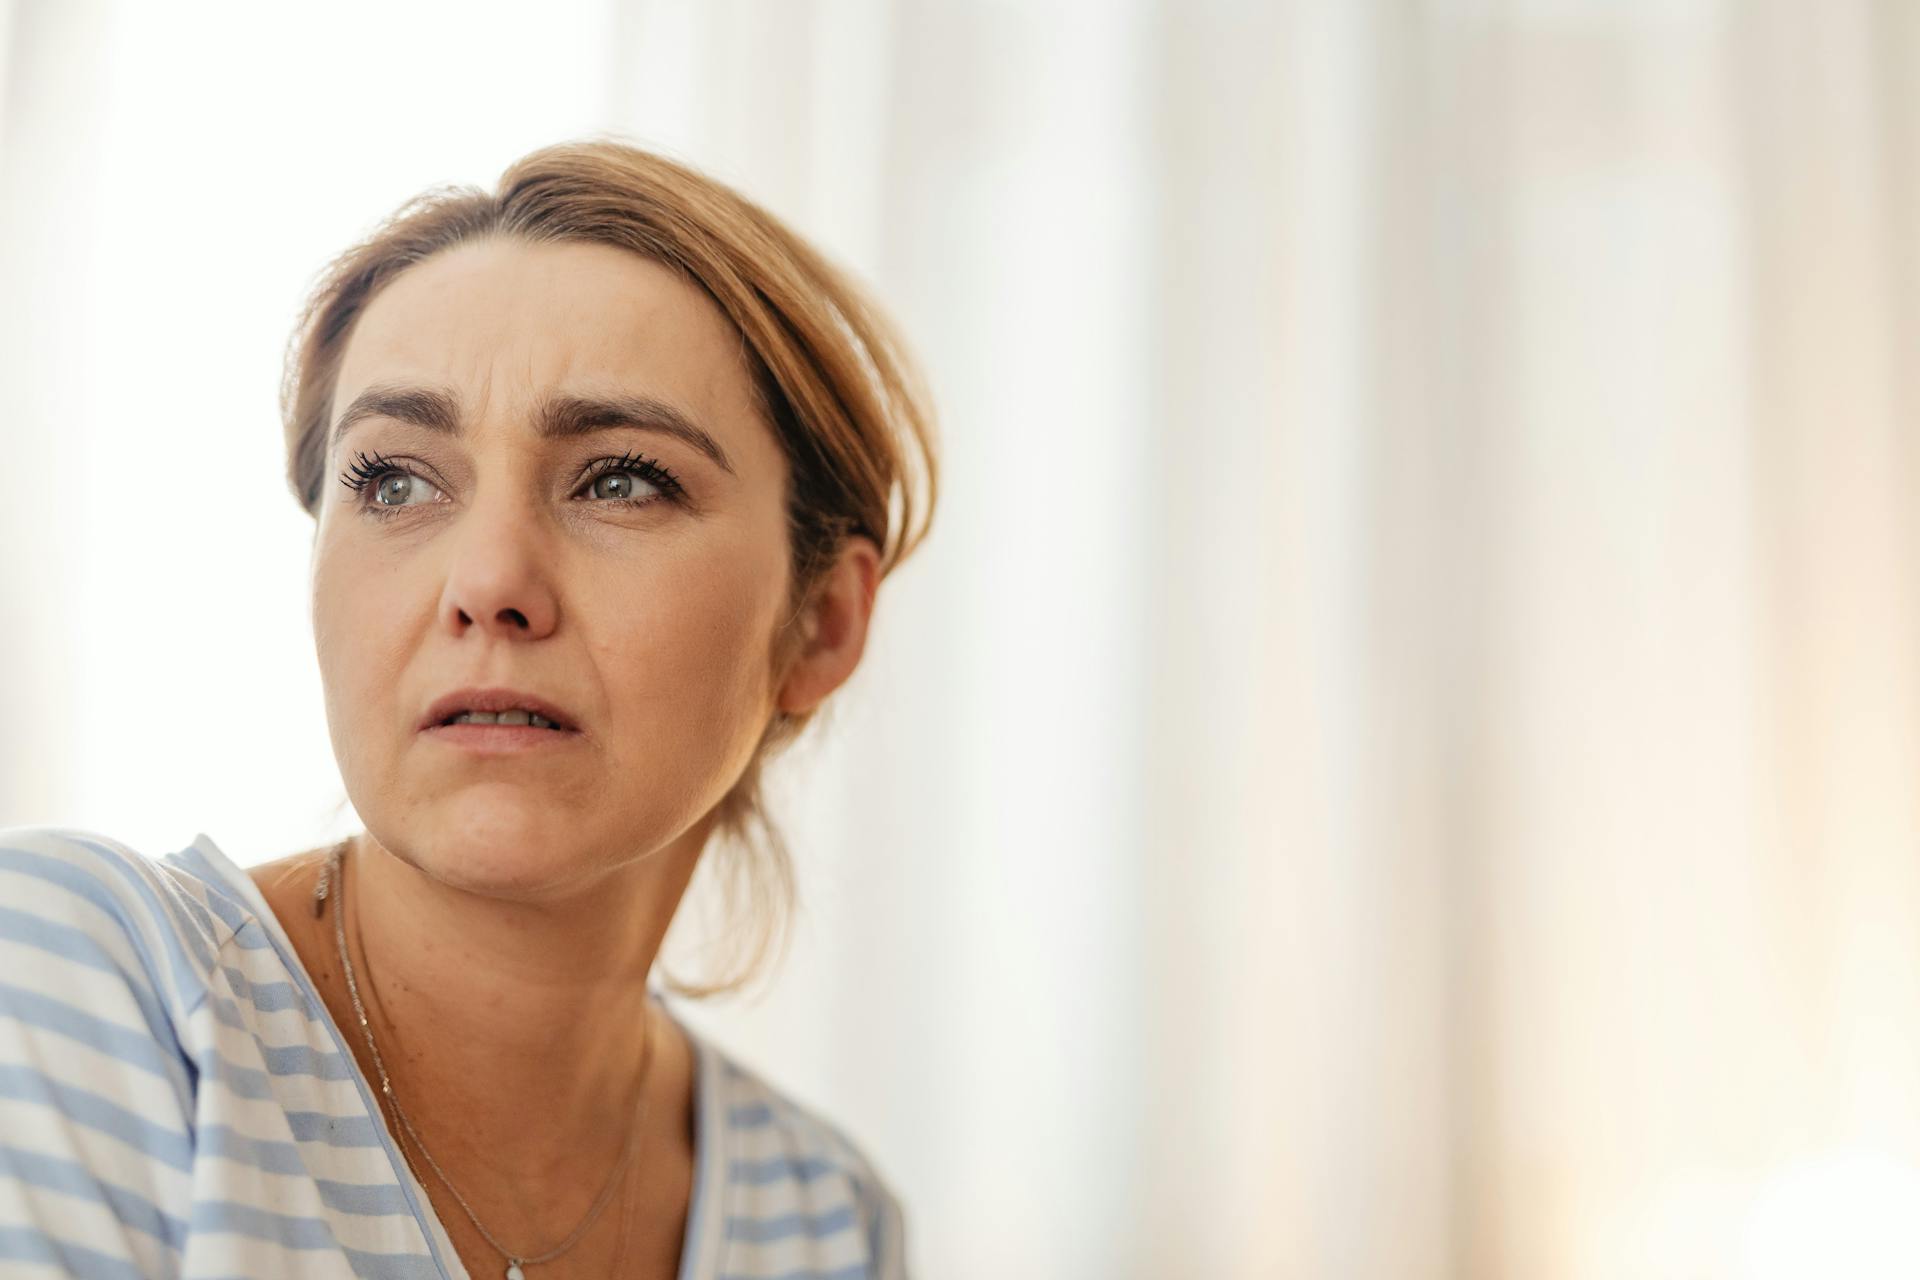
[{"left": 440, "top": 493, "right": 561, "bottom": 641}]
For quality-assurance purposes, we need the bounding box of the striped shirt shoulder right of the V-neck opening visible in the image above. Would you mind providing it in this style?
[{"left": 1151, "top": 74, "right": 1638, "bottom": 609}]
[{"left": 703, "top": 1042, "right": 904, "bottom": 1276}]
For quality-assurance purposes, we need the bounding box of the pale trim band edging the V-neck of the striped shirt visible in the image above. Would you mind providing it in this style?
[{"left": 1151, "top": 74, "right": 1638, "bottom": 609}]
[{"left": 172, "top": 831, "right": 724, "bottom": 1280}]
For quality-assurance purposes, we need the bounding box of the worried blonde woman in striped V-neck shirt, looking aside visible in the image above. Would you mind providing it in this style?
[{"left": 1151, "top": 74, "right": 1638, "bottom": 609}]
[{"left": 0, "top": 142, "right": 935, "bottom": 1280}]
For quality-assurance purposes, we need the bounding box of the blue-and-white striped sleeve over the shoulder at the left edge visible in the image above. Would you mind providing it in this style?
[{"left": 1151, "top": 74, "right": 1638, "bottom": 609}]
[{"left": 0, "top": 827, "right": 271, "bottom": 1276}]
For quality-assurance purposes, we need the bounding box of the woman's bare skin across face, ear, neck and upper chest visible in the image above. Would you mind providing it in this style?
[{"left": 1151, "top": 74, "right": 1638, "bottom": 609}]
[{"left": 252, "top": 238, "right": 879, "bottom": 1280}]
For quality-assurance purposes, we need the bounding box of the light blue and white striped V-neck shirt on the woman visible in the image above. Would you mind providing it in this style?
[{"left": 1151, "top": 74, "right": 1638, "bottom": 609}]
[{"left": 0, "top": 827, "right": 906, "bottom": 1280}]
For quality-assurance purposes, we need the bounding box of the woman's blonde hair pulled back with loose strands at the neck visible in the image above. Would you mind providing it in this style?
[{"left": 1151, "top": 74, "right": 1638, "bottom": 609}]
[{"left": 280, "top": 138, "right": 939, "bottom": 998}]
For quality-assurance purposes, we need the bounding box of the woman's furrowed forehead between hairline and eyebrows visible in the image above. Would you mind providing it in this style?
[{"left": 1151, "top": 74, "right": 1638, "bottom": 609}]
[{"left": 334, "top": 238, "right": 755, "bottom": 436}]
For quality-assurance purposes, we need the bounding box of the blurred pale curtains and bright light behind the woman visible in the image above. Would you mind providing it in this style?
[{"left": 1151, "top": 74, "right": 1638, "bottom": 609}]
[{"left": 0, "top": 0, "right": 1920, "bottom": 1280}]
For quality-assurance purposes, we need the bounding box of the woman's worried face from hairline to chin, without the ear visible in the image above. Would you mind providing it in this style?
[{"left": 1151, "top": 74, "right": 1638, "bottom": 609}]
[{"left": 313, "top": 238, "right": 789, "bottom": 898}]
